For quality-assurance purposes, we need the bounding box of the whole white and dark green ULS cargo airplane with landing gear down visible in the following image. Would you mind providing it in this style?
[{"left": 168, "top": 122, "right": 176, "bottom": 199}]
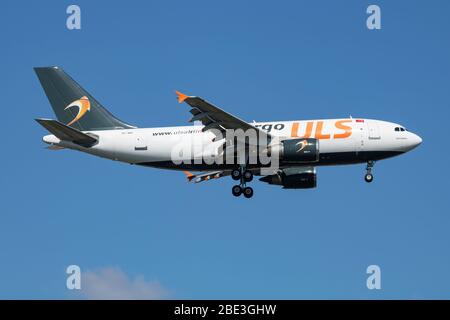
[{"left": 34, "top": 66, "right": 422, "bottom": 198}]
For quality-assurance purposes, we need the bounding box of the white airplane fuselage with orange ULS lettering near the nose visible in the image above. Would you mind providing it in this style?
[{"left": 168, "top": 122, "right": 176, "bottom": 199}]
[{"left": 44, "top": 118, "right": 422, "bottom": 171}]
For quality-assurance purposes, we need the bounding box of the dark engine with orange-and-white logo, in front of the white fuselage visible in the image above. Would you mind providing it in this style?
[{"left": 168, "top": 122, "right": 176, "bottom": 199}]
[{"left": 268, "top": 138, "right": 319, "bottom": 163}]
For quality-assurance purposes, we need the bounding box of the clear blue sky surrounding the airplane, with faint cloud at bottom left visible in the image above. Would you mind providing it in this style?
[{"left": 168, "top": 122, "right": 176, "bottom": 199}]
[{"left": 0, "top": 0, "right": 450, "bottom": 299}]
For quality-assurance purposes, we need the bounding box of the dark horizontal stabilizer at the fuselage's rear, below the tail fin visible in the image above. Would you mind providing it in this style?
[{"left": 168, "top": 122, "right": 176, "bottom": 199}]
[{"left": 36, "top": 119, "right": 98, "bottom": 148}]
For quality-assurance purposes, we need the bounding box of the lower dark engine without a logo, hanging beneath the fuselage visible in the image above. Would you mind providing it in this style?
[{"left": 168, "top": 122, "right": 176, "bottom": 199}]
[{"left": 259, "top": 167, "right": 317, "bottom": 189}]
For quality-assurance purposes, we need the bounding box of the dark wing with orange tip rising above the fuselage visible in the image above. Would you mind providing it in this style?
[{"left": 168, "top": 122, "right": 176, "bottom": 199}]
[{"left": 176, "top": 91, "right": 270, "bottom": 141}]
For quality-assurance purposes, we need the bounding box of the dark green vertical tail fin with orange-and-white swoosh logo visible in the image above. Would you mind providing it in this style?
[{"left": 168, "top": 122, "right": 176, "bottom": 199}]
[{"left": 34, "top": 67, "right": 134, "bottom": 131}]
